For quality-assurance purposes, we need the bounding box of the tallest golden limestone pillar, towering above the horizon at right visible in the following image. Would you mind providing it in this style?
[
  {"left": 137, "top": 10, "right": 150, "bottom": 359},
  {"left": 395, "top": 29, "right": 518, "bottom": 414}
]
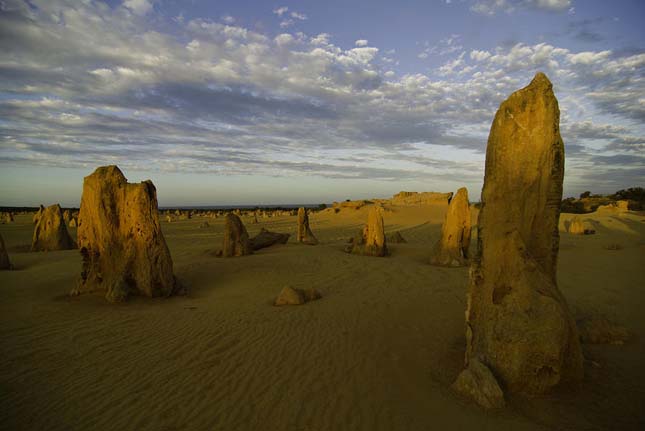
[{"left": 466, "top": 73, "right": 583, "bottom": 394}]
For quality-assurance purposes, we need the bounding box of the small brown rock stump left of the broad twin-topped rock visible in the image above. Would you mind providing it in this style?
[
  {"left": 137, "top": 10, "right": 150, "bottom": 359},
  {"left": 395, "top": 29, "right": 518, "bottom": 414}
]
[{"left": 31, "top": 204, "right": 75, "bottom": 251}]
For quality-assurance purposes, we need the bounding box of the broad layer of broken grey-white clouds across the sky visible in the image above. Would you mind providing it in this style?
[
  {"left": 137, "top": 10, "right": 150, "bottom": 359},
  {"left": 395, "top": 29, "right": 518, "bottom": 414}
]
[{"left": 0, "top": 0, "right": 645, "bottom": 197}]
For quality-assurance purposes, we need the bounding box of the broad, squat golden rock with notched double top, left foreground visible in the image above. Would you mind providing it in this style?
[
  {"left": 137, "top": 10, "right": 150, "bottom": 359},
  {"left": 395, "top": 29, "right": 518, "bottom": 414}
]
[{"left": 72, "top": 166, "right": 175, "bottom": 302}]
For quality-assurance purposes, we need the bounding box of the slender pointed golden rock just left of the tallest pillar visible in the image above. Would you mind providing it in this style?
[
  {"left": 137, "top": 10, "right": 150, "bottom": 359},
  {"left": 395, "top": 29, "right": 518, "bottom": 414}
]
[{"left": 430, "top": 187, "right": 471, "bottom": 266}]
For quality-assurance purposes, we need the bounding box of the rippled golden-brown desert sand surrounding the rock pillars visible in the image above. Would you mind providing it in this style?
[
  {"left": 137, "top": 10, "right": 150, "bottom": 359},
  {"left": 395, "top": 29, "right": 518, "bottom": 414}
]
[{"left": 0, "top": 204, "right": 645, "bottom": 431}]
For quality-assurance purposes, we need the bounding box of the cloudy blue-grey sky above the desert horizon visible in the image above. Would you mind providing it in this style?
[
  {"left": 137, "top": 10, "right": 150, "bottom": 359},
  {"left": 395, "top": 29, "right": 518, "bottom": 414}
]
[{"left": 0, "top": 0, "right": 645, "bottom": 206}]
